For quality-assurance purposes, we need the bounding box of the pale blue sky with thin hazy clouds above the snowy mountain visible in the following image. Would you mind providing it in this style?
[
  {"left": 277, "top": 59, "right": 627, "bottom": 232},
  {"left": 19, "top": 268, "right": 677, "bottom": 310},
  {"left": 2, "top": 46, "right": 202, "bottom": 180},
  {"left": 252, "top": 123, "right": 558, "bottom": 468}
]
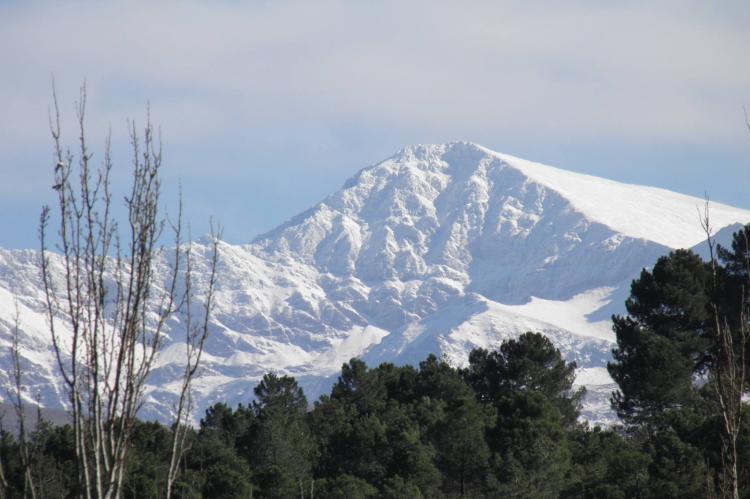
[{"left": 0, "top": 0, "right": 750, "bottom": 248}]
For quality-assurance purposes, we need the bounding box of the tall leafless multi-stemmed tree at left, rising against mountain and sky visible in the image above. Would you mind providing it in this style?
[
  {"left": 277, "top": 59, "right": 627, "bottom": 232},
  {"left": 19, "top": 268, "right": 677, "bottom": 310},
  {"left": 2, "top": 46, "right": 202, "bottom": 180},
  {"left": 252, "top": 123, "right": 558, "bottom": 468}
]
[{"left": 39, "top": 84, "right": 216, "bottom": 498}]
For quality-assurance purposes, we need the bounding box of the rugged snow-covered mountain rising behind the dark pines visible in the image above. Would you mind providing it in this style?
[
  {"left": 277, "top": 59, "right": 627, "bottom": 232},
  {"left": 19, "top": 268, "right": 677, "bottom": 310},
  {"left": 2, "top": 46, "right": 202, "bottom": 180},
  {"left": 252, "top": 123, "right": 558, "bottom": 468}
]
[{"left": 0, "top": 143, "right": 750, "bottom": 426}]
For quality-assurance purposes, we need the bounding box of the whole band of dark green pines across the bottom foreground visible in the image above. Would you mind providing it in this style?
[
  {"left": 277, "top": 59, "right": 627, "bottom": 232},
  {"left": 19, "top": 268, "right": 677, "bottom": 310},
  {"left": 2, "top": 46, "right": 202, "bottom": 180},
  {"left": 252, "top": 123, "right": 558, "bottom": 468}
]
[{"left": 0, "top": 226, "right": 750, "bottom": 499}]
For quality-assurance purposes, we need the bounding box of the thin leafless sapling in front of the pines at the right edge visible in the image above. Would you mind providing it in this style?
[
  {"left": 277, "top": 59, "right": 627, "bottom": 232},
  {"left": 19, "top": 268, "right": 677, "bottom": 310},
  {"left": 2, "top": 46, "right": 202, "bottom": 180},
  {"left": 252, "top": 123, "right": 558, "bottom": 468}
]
[{"left": 701, "top": 196, "right": 750, "bottom": 499}]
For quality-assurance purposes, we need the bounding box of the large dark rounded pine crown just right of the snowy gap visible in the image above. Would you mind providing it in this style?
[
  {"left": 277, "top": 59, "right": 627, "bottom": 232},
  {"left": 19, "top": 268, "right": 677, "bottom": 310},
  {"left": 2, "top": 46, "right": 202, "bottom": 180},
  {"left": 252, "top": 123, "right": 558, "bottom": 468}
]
[{"left": 608, "top": 250, "right": 711, "bottom": 424}]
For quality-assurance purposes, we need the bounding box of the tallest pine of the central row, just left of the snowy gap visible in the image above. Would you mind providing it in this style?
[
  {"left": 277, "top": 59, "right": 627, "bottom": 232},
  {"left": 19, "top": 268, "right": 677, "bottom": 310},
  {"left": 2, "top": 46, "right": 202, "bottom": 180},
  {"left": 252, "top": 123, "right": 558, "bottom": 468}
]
[{"left": 464, "top": 333, "right": 582, "bottom": 498}]
